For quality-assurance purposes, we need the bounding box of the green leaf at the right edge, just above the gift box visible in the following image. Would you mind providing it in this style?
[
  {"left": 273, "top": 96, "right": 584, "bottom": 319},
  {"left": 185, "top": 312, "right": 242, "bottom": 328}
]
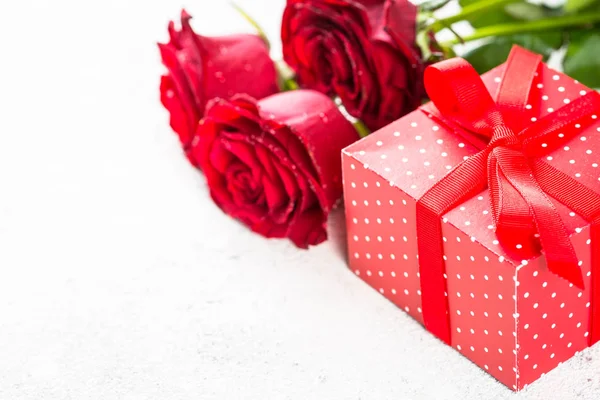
[{"left": 563, "top": 29, "right": 600, "bottom": 88}]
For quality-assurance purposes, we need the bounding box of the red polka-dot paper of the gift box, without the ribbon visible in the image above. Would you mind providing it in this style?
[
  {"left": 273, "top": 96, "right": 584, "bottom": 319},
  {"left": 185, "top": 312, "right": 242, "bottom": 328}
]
[{"left": 342, "top": 59, "right": 600, "bottom": 390}]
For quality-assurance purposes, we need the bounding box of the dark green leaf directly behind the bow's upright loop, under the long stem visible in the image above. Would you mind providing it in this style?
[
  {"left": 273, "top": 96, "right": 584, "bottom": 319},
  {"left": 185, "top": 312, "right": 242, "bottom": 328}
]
[{"left": 463, "top": 32, "right": 562, "bottom": 74}]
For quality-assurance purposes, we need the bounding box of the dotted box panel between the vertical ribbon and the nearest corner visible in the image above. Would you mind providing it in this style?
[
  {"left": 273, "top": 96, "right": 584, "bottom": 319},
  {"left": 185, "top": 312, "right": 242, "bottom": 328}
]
[{"left": 442, "top": 223, "right": 517, "bottom": 386}]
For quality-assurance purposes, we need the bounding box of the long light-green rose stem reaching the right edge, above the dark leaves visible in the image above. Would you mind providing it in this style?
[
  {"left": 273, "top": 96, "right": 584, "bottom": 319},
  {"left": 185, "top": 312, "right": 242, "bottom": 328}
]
[{"left": 443, "top": 12, "right": 600, "bottom": 46}]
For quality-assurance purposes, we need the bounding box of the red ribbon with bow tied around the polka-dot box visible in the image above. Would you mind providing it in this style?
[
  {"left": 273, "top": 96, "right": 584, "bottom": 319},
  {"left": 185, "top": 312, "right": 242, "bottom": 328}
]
[{"left": 417, "top": 46, "right": 600, "bottom": 345}]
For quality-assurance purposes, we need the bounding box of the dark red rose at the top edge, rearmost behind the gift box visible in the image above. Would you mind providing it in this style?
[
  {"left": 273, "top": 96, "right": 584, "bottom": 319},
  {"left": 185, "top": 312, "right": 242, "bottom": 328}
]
[{"left": 281, "top": 0, "right": 425, "bottom": 130}]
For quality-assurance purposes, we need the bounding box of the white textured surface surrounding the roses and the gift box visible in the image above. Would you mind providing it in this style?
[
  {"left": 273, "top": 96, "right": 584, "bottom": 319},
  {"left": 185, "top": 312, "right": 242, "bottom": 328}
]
[{"left": 0, "top": 0, "right": 600, "bottom": 400}]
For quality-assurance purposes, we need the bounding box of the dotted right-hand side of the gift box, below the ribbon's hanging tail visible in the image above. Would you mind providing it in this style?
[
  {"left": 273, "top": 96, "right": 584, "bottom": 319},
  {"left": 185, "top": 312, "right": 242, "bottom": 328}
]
[{"left": 517, "top": 228, "right": 591, "bottom": 387}]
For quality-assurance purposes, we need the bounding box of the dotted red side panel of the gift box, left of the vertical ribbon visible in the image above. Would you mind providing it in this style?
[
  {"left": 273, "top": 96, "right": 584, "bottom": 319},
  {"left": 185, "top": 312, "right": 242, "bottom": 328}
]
[{"left": 345, "top": 158, "right": 423, "bottom": 323}]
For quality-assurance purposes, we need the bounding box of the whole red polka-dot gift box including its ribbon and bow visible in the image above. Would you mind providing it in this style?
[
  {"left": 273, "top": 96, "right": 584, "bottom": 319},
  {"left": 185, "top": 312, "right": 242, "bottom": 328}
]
[{"left": 342, "top": 47, "right": 600, "bottom": 390}]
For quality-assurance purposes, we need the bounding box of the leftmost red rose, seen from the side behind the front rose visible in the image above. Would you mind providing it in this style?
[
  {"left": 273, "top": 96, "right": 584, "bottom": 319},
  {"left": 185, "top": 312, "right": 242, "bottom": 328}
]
[{"left": 159, "top": 11, "right": 279, "bottom": 163}]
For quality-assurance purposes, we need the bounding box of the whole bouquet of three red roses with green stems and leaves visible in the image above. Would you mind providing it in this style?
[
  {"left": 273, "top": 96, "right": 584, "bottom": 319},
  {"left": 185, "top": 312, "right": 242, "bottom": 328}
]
[{"left": 159, "top": 0, "right": 600, "bottom": 248}]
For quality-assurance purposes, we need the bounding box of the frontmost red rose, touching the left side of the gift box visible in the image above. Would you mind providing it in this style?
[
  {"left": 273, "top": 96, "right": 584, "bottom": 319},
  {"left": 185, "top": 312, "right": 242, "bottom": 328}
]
[{"left": 192, "top": 90, "right": 359, "bottom": 248}]
